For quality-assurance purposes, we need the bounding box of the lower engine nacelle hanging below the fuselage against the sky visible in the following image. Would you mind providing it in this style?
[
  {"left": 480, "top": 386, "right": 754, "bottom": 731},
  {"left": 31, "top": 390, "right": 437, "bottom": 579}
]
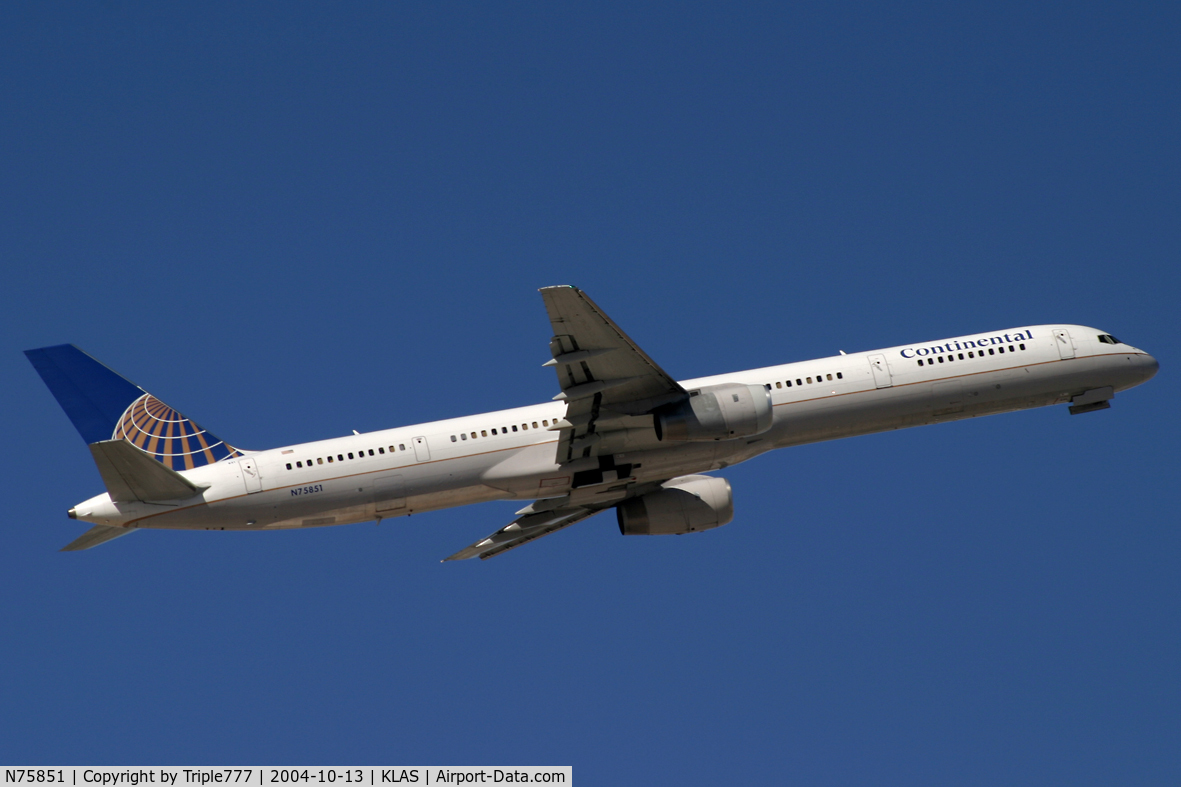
[{"left": 615, "top": 475, "right": 735, "bottom": 535}]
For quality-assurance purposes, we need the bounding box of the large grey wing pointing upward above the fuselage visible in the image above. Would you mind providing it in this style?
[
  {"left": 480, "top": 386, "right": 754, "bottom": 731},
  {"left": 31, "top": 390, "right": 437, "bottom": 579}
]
[{"left": 541, "top": 286, "right": 686, "bottom": 463}]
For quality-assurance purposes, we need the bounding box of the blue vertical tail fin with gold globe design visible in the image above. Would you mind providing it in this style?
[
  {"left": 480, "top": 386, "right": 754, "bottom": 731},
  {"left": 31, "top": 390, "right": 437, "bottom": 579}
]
[{"left": 25, "top": 344, "right": 241, "bottom": 470}]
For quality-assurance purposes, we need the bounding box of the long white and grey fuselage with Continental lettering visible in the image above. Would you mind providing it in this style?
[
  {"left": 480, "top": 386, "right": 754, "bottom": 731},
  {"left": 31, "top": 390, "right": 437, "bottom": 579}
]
[{"left": 74, "top": 325, "right": 1157, "bottom": 529}]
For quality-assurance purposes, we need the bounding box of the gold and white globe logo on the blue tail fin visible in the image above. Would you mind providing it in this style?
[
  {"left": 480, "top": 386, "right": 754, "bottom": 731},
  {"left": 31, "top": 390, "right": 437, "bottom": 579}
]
[{"left": 111, "top": 394, "right": 242, "bottom": 470}]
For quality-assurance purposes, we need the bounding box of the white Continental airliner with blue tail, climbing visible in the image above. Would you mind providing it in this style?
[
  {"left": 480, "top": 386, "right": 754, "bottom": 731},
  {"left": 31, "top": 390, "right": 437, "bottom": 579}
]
[{"left": 26, "top": 286, "right": 1159, "bottom": 560}]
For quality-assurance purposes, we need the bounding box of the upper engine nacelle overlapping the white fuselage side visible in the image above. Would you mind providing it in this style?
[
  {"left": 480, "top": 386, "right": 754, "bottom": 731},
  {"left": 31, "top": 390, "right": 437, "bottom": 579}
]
[{"left": 653, "top": 383, "right": 772, "bottom": 442}]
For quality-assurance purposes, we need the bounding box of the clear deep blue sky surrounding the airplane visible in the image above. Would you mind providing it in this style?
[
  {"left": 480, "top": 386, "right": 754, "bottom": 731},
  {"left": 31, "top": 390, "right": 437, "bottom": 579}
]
[{"left": 0, "top": 2, "right": 1181, "bottom": 785}]
